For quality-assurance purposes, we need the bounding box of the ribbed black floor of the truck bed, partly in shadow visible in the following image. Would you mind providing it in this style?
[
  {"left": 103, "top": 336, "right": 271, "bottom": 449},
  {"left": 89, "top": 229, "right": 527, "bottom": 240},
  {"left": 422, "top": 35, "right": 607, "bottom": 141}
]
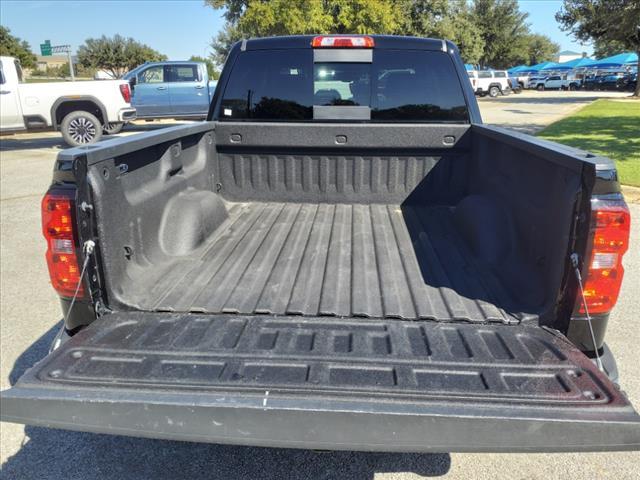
[{"left": 140, "top": 203, "right": 517, "bottom": 322}]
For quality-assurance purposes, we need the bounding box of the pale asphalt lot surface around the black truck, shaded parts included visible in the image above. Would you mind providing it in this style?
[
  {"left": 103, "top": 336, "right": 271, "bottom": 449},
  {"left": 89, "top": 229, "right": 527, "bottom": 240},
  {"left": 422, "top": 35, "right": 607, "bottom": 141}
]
[{"left": 0, "top": 92, "right": 640, "bottom": 480}]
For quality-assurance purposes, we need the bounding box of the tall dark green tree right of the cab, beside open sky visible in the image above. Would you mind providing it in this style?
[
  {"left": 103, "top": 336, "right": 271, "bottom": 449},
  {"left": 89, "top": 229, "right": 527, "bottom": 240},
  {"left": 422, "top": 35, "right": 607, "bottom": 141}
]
[{"left": 473, "top": 0, "right": 529, "bottom": 68}]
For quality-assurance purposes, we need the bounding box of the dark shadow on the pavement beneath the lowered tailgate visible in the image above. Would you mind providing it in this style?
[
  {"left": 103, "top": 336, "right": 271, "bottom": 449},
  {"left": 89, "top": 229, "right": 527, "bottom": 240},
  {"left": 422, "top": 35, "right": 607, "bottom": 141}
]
[{"left": 1, "top": 323, "right": 451, "bottom": 480}]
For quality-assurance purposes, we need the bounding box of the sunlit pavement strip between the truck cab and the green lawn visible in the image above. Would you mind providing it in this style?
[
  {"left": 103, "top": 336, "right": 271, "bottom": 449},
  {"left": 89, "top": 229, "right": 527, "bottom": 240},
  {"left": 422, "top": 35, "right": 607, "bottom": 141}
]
[{"left": 479, "top": 90, "right": 630, "bottom": 134}]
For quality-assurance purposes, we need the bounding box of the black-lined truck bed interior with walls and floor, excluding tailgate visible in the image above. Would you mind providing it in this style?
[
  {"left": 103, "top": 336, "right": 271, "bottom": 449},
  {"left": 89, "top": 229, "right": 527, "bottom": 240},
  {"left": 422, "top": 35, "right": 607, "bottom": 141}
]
[{"left": 95, "top": 124, "right": 582, "bottom": 330}]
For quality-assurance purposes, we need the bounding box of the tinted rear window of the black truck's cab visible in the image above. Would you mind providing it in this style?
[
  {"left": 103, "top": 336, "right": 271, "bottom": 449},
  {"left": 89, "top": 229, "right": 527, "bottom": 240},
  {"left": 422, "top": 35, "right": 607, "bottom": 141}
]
[{"left": 218, "top": 49, "right": 469, "bottom": 123}]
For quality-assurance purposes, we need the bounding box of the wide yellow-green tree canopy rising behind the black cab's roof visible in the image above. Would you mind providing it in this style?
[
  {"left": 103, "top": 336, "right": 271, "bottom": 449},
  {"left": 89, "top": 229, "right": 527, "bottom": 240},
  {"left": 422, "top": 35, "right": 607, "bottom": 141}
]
[{"left": 205, "top": 0, "right": 557, "bottom": 68}]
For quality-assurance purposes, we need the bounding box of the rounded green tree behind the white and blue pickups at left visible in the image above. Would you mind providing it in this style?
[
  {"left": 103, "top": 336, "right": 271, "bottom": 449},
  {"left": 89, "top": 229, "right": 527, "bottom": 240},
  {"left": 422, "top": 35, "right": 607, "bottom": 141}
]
[{"left": 78, "top": 35, "right": 167, "bottom": 78}]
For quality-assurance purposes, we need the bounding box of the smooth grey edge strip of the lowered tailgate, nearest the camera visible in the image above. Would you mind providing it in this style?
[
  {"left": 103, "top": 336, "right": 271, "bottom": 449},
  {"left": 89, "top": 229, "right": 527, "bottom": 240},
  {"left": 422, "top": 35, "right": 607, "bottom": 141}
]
[{"left": 2, "top": 382, "right": 640, "bottom": 452}]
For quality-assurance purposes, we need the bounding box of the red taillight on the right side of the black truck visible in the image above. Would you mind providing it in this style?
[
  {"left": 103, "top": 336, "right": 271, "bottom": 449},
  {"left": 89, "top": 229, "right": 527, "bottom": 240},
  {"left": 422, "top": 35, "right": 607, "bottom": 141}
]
[{"left": 578, "top": 201, "right": 631, "bottom": 314}]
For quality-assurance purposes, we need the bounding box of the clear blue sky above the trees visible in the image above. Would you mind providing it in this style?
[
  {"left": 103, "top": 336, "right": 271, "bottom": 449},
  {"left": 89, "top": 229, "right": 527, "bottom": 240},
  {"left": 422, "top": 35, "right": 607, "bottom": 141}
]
[{"left": 0, "top": 0, "right": 592, "bottom": 60}]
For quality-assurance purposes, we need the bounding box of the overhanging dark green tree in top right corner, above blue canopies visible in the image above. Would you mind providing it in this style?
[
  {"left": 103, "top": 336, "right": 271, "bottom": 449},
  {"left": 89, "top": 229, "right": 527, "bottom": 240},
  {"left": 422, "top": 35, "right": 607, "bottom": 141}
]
[{"left": 556, "top": 0, "right": 640, "bottom": 97}]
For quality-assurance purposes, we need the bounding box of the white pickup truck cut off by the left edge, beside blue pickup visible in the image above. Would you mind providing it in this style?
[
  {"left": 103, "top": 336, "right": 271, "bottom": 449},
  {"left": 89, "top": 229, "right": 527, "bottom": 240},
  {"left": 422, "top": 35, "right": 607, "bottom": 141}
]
[{"left": 0, "top": 57, "right": 136, "bottom": 146}]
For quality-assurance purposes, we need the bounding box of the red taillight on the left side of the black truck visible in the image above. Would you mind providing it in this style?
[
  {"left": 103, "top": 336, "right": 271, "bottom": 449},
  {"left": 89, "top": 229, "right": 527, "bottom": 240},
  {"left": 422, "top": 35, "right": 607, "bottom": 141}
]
[{"left": 42, "top": 190, "right": 84, "bottom": 297}]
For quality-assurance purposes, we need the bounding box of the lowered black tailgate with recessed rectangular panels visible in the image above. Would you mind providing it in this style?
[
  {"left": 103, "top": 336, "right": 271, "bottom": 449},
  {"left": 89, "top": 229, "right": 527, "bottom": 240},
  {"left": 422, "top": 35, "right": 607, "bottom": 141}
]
[{"left": 1, "top": 313, "right": 640, "bottom": 452}]
